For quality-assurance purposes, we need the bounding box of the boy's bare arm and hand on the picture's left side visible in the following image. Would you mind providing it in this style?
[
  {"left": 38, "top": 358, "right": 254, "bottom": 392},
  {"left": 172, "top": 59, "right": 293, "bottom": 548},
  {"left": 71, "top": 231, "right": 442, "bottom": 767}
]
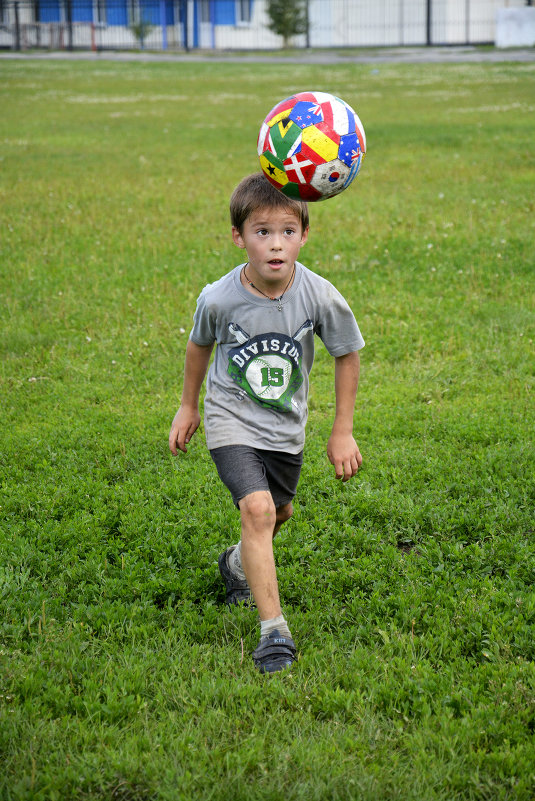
[{"left": 169, "top": 339, "right": 214, "bottom": 455}]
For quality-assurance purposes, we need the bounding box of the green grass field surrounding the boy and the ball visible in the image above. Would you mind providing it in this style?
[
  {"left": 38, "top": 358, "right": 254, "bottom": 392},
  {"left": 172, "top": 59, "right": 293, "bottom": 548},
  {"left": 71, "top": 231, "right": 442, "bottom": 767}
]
[{"left": 0, "top": 59, "right": 535, "bottom": 801}]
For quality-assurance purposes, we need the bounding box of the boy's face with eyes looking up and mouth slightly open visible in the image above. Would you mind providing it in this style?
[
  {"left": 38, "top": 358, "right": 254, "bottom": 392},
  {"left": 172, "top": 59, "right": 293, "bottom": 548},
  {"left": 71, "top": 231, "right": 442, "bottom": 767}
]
[{"left": 232, "top": 209, "right": 308, "bottom": 295}]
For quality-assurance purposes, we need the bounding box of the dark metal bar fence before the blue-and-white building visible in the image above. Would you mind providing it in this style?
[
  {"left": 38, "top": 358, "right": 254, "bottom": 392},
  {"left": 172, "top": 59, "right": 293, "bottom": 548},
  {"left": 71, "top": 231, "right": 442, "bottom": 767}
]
[{"left": 0, "top": 0, "right": 531, "bottom": 51}]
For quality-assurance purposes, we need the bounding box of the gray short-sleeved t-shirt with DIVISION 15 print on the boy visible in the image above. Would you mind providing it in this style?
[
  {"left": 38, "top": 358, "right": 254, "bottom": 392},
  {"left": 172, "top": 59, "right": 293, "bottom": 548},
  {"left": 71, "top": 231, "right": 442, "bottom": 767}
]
[{"left": 190, "top": 262, "right": 364, "bottom": 453}]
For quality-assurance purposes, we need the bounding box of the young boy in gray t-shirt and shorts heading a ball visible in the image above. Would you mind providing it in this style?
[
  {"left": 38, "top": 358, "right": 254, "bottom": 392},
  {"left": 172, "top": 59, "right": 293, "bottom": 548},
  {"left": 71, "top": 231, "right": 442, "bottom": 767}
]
[{"left": 169, "top": 173, "right": 364, "bottom": 673}]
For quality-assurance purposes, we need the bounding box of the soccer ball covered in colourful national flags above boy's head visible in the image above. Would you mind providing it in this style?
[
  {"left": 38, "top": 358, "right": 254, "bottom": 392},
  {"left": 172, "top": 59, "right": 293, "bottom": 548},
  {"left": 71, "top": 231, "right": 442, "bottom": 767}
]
[{"left": 258, "top": 92, "right": 366, "bottom": 201}]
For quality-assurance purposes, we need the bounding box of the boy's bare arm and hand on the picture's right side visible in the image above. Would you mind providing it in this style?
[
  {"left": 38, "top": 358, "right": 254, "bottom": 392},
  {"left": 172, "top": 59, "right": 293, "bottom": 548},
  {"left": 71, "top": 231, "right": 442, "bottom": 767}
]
[{"left": 327, "top": 350, "right": 362, "bottom": 481}]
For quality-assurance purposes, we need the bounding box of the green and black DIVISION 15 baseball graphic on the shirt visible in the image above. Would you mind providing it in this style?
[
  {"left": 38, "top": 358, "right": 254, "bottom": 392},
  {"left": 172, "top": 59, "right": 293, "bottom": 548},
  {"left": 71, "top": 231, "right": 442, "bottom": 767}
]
[{"left": 228, "top": 333, "right": 303, "bottom": 412}]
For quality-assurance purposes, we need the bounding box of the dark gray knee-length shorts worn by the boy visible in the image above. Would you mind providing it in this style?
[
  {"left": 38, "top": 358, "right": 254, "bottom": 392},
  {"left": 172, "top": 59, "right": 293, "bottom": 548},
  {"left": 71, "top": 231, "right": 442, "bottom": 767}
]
[{"left": 210, "top": 445, "right": 303, "bottom": 508}]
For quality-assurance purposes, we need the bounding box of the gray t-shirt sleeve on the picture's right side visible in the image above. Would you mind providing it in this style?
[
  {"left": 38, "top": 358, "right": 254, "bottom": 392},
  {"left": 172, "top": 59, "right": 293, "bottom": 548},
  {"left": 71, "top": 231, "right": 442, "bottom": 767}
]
[{"left": 315, "top": 282, "right": 364, "bottom": 357}]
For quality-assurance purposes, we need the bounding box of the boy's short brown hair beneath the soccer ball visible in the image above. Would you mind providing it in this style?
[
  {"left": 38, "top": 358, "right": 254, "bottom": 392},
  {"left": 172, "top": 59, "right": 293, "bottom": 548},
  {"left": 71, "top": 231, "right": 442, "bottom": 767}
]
[{"left": 230, "top": 172, "right": 309, "bottom": 234}]
